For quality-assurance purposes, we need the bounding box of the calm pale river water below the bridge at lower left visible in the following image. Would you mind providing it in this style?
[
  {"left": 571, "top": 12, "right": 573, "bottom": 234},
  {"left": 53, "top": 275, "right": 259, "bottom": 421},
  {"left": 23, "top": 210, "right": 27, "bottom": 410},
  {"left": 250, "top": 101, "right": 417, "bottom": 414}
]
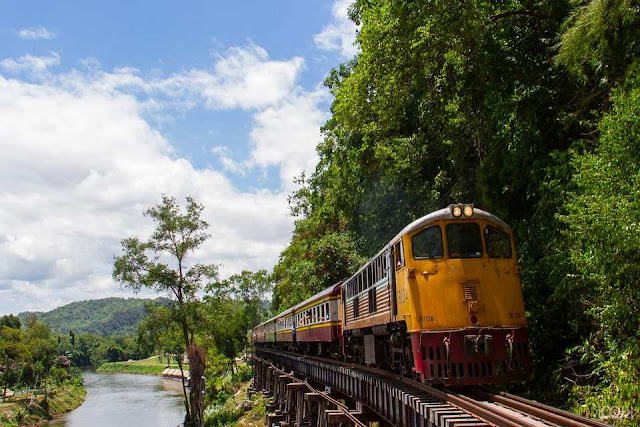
[{"left": 45, "top": 372, "right": 185, "bottom": 427}]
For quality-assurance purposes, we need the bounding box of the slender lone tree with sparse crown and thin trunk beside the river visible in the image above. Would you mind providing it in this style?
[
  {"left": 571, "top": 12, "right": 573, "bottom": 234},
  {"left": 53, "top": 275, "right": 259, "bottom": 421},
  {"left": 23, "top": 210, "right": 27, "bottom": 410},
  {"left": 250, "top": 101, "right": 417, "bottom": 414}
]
[{"left": 113, "top": 196, "right": 218, "bottom": 426}]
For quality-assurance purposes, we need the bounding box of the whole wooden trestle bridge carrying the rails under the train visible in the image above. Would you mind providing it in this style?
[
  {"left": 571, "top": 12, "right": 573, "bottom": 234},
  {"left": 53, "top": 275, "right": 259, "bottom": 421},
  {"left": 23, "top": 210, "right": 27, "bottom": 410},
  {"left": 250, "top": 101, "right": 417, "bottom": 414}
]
[{"left": 252, "top": 349, "right": 607, "bottom": 427}]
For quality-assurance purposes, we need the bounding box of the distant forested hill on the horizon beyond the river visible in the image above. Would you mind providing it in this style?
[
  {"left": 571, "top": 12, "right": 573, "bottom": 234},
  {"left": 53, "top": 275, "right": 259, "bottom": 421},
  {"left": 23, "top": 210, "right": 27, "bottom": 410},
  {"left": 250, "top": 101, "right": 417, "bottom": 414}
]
[{"left": 18, "top": 298, "right": 171, "bottom": 335}]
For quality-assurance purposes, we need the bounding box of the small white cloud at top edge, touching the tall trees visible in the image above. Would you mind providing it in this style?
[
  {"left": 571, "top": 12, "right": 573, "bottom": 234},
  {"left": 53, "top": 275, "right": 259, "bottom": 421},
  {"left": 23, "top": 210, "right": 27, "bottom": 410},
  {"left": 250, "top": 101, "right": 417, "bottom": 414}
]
[{"left": 313, "top": 0, "right": 358, "bottom": 58}]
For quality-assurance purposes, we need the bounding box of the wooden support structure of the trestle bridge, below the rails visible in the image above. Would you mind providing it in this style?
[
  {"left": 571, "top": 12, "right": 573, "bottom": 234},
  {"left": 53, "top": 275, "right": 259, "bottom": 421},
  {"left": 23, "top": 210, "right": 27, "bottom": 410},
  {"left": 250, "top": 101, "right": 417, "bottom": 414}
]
[{"left": 254, "top": 350, "right": 488, "bottom": 427}]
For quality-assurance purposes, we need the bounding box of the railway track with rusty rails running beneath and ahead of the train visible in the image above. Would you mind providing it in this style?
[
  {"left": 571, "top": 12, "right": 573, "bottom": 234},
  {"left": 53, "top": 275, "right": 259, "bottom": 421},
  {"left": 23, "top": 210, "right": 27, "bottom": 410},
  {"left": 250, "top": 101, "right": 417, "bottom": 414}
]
[{"left": 252, "top": 350, "right": 608, "bottom": 427}]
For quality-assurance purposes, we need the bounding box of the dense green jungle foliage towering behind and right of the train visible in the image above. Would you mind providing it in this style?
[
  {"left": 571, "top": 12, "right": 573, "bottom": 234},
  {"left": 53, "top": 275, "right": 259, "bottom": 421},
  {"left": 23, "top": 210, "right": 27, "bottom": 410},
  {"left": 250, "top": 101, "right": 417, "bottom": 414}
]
[{"left": 274, "top": 0, "right": 640, "bottom": 425}]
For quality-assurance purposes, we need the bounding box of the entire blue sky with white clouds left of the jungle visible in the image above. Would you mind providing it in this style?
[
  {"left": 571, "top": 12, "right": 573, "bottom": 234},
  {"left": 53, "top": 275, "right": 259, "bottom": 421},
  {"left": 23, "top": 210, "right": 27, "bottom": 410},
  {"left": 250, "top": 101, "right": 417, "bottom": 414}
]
[{"left": 0, "top": 0, "right": 357, "bottom": 314}]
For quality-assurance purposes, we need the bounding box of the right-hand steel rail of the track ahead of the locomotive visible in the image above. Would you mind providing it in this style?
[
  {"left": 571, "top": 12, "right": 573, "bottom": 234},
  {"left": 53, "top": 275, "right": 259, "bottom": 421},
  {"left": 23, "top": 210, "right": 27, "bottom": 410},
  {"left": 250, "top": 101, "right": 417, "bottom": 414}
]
[{"left": 469, "top": 387, "right": 609, "bottom": 427}]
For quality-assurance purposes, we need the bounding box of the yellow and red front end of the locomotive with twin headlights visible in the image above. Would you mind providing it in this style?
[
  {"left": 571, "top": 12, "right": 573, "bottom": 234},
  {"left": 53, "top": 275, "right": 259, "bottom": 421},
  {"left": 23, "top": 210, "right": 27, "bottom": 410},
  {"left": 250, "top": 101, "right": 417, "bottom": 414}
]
[{"left": 400, "top": 205, "right": 530, "bottom": 385}]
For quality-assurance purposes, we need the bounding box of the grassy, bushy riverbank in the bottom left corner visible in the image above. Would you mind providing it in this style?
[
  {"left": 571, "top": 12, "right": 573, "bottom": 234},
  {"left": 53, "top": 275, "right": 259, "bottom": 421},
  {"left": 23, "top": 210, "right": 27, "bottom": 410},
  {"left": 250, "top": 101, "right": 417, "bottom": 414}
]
[{"left": 0, "top": 381, "right": 86, "bottom": 427}]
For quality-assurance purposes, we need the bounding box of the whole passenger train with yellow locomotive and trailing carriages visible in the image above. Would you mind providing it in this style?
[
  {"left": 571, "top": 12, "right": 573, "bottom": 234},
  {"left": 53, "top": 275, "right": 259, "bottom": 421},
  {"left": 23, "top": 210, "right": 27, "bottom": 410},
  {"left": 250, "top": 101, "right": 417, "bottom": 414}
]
[{"left": 251, "top": 204, "right": 531, "bottom": 386}]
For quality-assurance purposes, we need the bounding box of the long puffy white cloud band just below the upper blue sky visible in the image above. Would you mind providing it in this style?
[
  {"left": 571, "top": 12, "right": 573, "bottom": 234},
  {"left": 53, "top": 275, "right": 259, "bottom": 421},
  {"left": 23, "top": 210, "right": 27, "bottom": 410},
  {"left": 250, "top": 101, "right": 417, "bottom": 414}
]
[{"left": 41, "top": 43, "right": 304, "bottom": 110}]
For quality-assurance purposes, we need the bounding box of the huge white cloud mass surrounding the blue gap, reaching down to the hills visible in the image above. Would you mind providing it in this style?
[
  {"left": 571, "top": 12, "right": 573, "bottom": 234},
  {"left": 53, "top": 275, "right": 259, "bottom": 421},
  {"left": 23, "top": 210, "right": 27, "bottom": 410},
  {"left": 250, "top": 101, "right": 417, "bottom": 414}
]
[{"left": 0, "top": 45, "right": 326, "bottom": 313}]
